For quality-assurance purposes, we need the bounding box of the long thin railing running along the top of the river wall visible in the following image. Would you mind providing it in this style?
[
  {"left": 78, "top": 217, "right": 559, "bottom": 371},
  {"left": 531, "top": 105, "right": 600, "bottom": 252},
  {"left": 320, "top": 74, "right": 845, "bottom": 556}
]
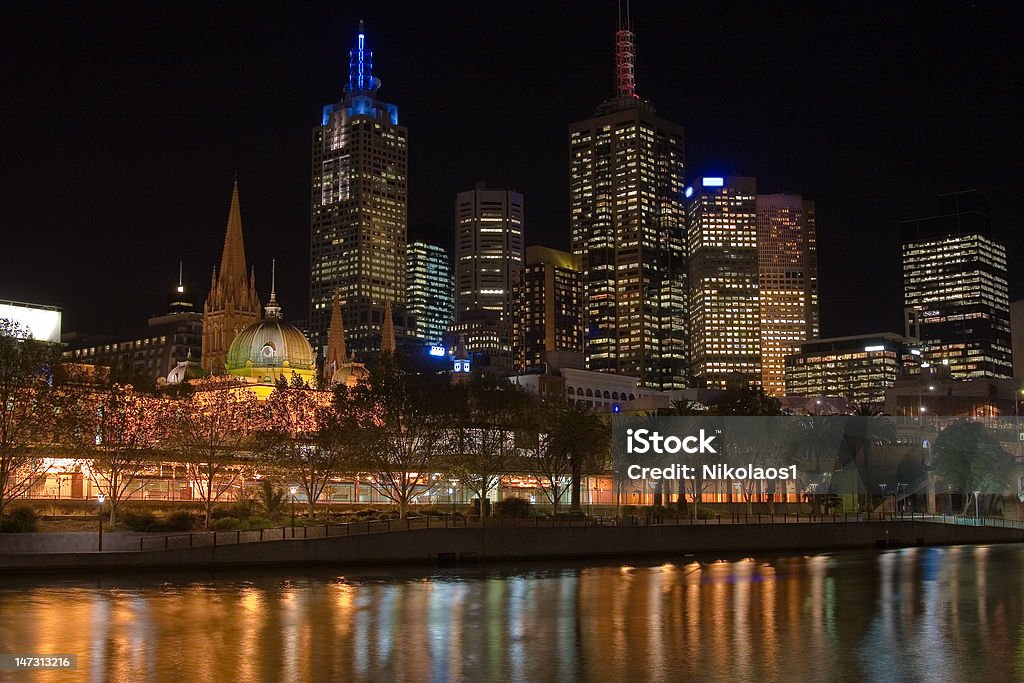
[{"left": 130, "top": 512, "right": 1024, "bottom": 551}]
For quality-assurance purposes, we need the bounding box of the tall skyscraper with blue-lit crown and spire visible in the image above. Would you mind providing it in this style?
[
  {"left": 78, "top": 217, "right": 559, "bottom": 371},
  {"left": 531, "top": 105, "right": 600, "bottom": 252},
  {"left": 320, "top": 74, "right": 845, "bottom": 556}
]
[{"left": 309, "top": 22, "right": 408, "bottom": 357}]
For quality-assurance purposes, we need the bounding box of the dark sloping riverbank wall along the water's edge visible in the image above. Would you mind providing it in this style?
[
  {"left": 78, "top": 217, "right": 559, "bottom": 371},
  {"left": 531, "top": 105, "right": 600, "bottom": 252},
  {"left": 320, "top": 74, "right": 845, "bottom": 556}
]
[{"left": 0, "top": 520, "right": 1024, "bottom": 573}]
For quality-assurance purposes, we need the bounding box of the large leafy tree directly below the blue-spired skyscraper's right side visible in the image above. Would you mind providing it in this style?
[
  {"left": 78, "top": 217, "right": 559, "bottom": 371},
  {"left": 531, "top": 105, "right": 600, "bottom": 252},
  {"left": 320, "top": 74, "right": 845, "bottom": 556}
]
[{"left": 348, "top": 353, "right": 451, "bottom": 517}]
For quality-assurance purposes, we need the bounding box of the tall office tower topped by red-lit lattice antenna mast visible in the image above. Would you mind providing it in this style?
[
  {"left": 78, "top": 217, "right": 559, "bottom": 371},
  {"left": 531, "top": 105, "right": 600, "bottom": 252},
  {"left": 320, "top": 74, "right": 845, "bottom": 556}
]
[{"left": 569, "top": 17, "right": 688, "bottom": 389}]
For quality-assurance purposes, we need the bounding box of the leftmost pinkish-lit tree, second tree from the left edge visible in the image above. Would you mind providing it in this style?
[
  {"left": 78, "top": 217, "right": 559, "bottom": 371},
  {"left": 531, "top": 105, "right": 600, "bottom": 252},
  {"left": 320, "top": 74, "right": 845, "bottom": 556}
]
[{"left": 79, "top": 384, "right": 171, "bottom": 524}]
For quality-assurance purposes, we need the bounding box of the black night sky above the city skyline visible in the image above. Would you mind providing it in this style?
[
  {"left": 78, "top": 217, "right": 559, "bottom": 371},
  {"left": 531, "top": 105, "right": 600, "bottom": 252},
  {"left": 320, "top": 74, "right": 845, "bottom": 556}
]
[{"left": 0, "top": 0, "right": 1024, "bottom": 336}]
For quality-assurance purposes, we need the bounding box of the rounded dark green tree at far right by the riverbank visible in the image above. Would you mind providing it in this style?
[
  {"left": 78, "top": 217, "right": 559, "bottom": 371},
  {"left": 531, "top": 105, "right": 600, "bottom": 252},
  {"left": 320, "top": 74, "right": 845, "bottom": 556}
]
[{"left": 932, "top": 420, "right": 1015, "bottom": 513}]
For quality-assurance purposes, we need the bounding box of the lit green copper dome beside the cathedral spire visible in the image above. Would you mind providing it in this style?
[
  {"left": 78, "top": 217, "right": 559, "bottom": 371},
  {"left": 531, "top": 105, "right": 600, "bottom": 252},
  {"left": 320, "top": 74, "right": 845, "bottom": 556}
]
[{"left": 225, "top": 316, "right": 316, "bottom": 374}]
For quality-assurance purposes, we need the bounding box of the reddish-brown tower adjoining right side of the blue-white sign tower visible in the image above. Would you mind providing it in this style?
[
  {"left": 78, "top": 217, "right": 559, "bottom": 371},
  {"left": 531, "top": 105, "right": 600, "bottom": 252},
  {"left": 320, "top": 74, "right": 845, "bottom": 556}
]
[{"left": 757, "top": 195, "right": 818, "bottom": 396}]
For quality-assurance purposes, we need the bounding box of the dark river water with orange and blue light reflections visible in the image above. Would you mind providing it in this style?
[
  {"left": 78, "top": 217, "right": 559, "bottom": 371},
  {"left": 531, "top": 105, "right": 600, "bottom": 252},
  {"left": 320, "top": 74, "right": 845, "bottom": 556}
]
[{"left": 0, "top": 545, "right": 1024, "bottom": 682}]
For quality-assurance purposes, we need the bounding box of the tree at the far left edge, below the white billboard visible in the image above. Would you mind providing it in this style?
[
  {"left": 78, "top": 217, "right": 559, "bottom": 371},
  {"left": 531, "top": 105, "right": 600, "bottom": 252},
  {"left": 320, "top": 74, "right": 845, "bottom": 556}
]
[{"left": 0, "top": 318, "right": 66, "bottom": 518}]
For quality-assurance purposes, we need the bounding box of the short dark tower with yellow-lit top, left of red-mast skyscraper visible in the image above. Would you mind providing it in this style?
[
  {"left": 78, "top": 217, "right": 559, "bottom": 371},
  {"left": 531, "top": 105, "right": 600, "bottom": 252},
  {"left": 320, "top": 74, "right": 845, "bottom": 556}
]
[{"left": 512, "top": 247, "right": 583, "bottom": 373}]
